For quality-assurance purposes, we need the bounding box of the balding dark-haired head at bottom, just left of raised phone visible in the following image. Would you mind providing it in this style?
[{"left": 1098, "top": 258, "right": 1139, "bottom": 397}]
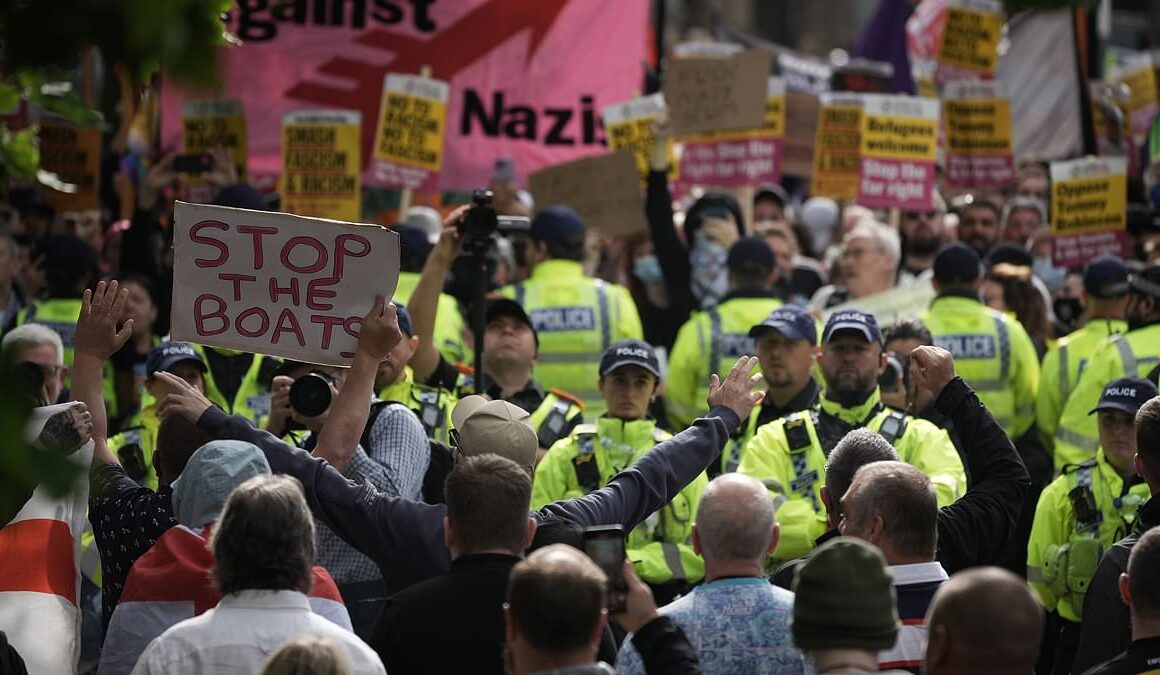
[{"left": 507, "top": 544, "right": 608, "bottom": 654}]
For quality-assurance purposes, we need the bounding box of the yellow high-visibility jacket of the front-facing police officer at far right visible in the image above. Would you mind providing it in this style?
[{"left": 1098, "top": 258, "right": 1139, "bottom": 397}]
[{"left": 1027, "top": 450, "right": 1151, "bottom": 622}]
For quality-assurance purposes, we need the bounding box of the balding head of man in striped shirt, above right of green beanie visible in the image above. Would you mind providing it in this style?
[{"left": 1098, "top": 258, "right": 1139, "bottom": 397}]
[{"left": 841, "top": 462, "right": 938, "bottom": 565}]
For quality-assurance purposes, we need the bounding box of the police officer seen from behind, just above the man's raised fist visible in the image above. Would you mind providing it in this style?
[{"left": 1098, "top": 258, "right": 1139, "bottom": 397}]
[{"left": 922, "top": 242, "right": 1039, "bottom": 440}]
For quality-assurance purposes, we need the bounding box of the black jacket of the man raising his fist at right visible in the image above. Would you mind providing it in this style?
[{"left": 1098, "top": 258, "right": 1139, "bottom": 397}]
[{"left": 773, "top": 377, "right": 1031, "bottom": 588}]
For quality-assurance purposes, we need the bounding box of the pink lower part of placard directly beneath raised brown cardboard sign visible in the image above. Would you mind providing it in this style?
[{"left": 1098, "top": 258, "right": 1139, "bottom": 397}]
[{"left": 680, "top": 137, "right": 784, "bottom": 188}]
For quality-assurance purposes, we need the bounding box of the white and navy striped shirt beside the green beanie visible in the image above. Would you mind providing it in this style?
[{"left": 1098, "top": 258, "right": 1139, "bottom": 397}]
[{"left": 878, "top": 563, "right": 948, "bottom": 674}]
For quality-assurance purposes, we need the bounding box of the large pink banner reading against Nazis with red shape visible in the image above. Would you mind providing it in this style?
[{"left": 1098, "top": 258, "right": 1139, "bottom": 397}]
[{"left": 161, "top": 0, "right": 648, "bottom": 189}]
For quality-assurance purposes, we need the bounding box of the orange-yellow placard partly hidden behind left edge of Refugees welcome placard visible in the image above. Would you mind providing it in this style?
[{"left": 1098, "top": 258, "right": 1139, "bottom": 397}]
[{"left": 810, "top": 94, "right": 862, "bottom": 199}]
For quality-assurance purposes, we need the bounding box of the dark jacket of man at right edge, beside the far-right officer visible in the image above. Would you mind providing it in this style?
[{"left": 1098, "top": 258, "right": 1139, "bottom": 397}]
[{"left": 1072, "top": 495, "right": 1160, "bottom": 673}]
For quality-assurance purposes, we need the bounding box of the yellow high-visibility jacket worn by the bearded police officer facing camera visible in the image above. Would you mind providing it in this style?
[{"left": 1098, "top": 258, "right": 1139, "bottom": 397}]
[{"left": 738, "top": 389, "right": 966, "bottom": 563}]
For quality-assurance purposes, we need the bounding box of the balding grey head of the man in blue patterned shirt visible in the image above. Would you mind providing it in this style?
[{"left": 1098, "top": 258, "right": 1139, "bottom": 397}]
[{"left": 694, "top": 473, "right": 775, "bottom": 564}]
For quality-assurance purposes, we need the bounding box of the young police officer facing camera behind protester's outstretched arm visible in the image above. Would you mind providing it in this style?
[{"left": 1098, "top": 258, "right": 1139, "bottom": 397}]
[{"left": 531, "top": 340, "right": 709, "bottom": 602}]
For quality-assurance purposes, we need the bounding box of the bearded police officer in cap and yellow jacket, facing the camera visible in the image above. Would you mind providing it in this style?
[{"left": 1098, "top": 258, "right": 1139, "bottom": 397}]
[{"left": 738, "top": 310, "right": 966, "bottom": 563}]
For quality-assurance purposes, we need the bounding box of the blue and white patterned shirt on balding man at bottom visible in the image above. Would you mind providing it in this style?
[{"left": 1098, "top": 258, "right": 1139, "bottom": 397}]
[{"left": 616, "top": 576, "right": 812, "bottom": 675}]
